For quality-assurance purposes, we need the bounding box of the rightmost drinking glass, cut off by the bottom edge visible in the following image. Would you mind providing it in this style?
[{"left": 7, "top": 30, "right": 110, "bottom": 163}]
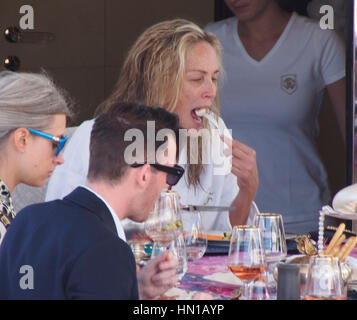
[{"left": 305, "top": 256, "right": 346, "bottom": 300}]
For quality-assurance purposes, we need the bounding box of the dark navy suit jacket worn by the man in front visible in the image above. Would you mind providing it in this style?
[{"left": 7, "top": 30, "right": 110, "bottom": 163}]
[{"left": 0, "top": 187, "right": 138, "bottom": 299}]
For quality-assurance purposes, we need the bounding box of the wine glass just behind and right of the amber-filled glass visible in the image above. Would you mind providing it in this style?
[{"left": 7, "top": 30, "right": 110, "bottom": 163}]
[{"left": 253, "top": 213, "right": 287, "bottom": 297}]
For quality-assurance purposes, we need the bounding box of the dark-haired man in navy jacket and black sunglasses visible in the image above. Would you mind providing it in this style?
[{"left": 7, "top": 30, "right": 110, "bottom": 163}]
[{"left": 0, "top": 103, "right": 183, "bottom": 299}]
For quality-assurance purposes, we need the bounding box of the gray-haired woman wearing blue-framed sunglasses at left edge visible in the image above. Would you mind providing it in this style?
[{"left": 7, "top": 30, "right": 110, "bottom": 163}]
[{"left": 0, "top": 71, "right": 71, "bottom": 243}]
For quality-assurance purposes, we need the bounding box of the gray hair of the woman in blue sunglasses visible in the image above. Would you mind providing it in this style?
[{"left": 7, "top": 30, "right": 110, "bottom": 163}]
[{"left": 0, "top": 71, "right": 73, "bottom": 144}]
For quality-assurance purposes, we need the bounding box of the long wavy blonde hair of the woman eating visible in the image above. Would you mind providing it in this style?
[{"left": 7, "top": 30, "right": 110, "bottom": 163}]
[{"left": 95, "top": 19, "right": 223, "bottom": 186}]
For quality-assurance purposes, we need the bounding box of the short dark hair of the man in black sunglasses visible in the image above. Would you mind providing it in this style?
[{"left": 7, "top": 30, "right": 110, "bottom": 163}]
[{"left": 88, "top": 102, "right": 180, "bottom": 182}]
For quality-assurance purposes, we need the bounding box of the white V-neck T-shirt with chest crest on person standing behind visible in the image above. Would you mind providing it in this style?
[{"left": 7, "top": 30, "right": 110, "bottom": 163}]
[{"left": 205, "top": 13, "right": 345, "bottom": 232}]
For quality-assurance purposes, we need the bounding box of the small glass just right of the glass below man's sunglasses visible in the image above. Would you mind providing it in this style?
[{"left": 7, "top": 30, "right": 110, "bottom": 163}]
[{"left": 181, "top": 210, "right": 207, "bottom": 260}]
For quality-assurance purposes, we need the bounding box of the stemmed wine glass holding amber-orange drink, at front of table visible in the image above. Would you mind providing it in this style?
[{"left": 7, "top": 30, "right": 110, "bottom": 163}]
[{"left": 227, "top": 226, "right": 266, "bottom": 300}]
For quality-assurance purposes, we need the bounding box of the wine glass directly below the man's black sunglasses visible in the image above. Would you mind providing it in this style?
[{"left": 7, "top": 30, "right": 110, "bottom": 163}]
[{"left": 144, "top": 190, "right": 182, "bottom": 249}]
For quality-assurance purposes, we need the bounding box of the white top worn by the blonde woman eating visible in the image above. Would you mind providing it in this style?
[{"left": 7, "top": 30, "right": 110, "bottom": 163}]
[{"left": 46, "top": 119, "right": 258, "bottom": 230}]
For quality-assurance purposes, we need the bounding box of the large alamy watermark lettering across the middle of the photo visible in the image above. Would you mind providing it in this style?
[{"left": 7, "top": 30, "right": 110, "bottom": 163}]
[{"left": 124, "top": 121, "right": 232, "bottom": 175}]
